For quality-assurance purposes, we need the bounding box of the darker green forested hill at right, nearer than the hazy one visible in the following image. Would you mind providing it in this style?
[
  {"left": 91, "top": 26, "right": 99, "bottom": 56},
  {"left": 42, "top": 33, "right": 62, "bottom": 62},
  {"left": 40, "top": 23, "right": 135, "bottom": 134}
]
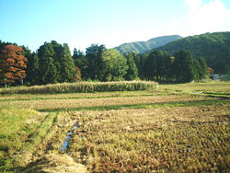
[{"left": 157, "top": 32, "right": 230, "bottom": 73}]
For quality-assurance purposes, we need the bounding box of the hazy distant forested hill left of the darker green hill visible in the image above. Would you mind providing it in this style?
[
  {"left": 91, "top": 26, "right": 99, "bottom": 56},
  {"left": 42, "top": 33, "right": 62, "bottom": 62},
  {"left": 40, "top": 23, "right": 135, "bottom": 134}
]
[{"left": 114, "top": 35, "right": 182, "bottom": 54}]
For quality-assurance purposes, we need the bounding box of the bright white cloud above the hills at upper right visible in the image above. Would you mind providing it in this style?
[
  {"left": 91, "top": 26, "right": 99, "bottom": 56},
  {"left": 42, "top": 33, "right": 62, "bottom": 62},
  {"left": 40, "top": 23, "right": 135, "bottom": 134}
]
[{"left": 170, "top": 0, "right": 230, "bottom": 36}]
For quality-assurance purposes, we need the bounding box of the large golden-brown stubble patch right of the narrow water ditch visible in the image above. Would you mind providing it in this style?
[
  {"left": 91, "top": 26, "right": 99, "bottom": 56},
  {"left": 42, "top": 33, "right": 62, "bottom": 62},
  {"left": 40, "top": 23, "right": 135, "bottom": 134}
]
[{"left": 71, "top": 105, "right": 230, "bottom": 172}]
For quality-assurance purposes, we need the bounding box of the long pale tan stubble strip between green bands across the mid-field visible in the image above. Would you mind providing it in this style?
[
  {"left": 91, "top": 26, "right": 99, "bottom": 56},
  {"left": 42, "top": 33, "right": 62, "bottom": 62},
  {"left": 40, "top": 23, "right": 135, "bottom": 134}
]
[{"left": 0, "top": 95, "right": 214, "bottom": 111}]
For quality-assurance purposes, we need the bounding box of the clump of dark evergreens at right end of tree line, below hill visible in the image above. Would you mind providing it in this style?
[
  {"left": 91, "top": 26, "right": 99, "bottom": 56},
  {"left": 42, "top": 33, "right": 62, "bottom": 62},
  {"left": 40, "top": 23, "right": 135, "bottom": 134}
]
[{"left": 139, "top": 50, "right": 207, "bottom": 82}]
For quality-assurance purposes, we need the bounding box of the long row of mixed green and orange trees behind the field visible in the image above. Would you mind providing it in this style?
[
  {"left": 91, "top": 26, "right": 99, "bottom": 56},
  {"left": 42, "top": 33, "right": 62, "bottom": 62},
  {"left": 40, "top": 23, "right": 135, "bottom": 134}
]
[{"left": 0, "top": 41, "right": 208, "bottom": 86}]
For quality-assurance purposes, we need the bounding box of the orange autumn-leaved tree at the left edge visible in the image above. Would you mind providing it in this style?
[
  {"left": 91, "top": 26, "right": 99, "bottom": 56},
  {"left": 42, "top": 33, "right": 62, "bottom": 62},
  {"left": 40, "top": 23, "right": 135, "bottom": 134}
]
[{"left": 0, "top": 45, "right": 27, "bottom": 83}]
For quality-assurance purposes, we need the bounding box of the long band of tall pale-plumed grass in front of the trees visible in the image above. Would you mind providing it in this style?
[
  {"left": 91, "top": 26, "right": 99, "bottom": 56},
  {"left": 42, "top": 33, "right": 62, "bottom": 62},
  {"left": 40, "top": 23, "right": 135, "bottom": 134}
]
[{"left": 0, "top": 81, "right": 158, "bottom": 94}]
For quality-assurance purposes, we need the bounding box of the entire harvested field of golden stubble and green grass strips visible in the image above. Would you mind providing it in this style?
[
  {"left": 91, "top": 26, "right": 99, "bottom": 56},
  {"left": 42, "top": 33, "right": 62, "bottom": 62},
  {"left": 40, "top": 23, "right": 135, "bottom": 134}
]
[{"left": 0, "top": 82, "right": 230, "bottom": 172}]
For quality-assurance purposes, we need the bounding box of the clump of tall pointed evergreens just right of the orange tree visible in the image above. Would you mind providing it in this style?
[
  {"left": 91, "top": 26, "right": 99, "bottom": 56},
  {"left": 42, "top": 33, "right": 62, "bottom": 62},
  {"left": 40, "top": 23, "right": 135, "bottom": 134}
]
[{"left": 38, "top": 41, "right": 76, "bottom": 84}]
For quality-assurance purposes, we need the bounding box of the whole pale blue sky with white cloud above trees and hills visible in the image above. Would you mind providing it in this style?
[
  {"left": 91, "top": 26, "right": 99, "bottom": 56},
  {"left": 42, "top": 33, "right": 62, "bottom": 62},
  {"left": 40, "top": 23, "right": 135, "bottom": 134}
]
[{"left": 0, "top": 0, "right": 230, "bottom": 51}]
